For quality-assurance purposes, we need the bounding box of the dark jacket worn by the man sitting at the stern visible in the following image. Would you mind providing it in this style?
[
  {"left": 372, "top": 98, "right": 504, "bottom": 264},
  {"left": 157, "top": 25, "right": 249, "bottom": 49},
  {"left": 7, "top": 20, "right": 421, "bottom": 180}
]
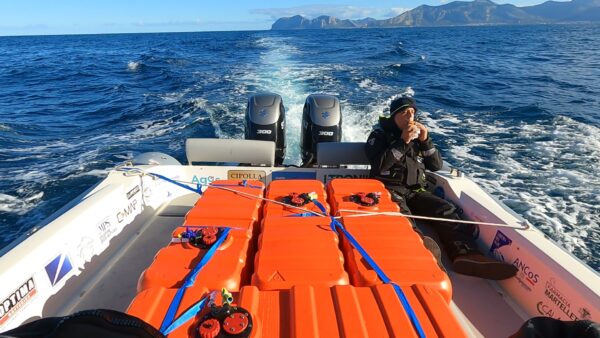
[{"left": 365, "top": 118, "right": 444, "bottom": 194}]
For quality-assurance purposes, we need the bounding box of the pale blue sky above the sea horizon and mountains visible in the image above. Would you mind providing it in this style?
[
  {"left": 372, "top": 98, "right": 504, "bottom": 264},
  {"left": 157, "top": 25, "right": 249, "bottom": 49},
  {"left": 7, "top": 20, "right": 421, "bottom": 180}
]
[{"left": 0, "top": 0, "right": 556, "bottom": 35}]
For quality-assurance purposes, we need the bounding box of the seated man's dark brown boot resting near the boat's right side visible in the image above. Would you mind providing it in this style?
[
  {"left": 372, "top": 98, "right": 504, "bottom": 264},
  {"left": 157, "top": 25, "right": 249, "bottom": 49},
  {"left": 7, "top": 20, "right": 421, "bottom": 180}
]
[{"left": 448, "top": 242, "right": 518, "bottom": 280}]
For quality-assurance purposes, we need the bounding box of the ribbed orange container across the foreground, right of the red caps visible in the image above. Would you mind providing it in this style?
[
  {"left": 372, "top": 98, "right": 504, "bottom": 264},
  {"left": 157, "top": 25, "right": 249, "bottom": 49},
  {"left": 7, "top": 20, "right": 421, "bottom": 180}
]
[{"left": 239, "top": 284, "right": 466, "bottom": 338}]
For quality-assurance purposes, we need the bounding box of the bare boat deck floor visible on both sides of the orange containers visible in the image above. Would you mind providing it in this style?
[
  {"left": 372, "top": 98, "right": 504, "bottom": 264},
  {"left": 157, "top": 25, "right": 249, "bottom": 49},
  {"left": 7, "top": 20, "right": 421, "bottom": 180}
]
[{"left": 43, "top": 194, "right": 524, "bottom": 337}]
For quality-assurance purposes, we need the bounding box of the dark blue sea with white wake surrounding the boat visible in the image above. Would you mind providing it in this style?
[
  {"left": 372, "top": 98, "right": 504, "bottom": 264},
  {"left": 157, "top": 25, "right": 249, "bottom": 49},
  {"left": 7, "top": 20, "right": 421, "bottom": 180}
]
[{"left": 0, "top": 24, "right": 600, "bottom": 271}]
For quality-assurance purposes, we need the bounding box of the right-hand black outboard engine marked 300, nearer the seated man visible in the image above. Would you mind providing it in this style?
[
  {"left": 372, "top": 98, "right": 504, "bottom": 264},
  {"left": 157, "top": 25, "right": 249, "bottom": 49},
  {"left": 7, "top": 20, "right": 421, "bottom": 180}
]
[{"left": 300, "top": 94, "right": 342, "bottom": 167}]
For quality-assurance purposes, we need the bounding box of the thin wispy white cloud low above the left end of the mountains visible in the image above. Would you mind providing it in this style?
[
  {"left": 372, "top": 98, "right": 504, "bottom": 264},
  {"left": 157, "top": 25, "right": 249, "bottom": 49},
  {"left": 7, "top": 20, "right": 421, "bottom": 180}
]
[{"left": 250, "top": 5, "right": 407, "bottom": 20}]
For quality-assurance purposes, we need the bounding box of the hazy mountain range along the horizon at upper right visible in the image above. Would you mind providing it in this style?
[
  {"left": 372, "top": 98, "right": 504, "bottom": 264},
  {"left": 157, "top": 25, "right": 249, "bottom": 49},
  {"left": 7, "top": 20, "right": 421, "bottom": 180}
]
[{"left": 271, "top": 0, "right": 600, "bottom": 30}]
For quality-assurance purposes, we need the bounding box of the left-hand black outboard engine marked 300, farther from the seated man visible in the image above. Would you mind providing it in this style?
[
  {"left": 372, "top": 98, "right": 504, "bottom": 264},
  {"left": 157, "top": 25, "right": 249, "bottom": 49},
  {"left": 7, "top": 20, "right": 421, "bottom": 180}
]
[{"left": 245, "top": 93, "right": 285, "bottom": 166}]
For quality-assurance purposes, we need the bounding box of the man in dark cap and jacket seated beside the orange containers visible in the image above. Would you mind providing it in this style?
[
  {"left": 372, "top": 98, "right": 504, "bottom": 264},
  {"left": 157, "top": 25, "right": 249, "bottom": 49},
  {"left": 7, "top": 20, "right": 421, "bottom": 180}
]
[{"left": 365, "top": 97, "right": 517, "bottom": 280}]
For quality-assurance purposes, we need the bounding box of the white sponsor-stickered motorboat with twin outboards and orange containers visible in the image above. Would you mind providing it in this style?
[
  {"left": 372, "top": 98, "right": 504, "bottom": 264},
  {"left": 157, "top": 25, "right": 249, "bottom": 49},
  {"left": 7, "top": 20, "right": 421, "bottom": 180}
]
[{"left": 0, "top": 94, "right": 600, "bottom": 337}]
